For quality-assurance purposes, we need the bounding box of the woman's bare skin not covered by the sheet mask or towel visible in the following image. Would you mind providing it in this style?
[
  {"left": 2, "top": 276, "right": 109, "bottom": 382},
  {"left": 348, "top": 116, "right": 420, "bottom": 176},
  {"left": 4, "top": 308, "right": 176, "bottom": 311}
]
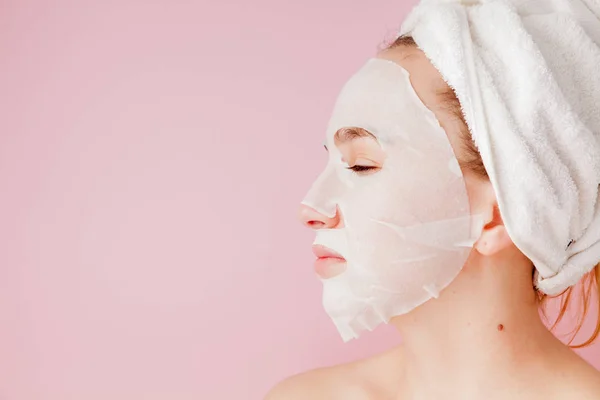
[{"left": 266, "top": 47, "right": 600, "bottom": 400}]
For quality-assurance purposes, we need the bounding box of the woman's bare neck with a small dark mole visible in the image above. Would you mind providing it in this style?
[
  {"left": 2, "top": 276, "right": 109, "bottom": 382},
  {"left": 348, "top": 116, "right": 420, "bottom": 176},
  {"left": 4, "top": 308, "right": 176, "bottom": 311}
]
[{"left": 392, "top": 248, "right": 565, "bottom": 399}]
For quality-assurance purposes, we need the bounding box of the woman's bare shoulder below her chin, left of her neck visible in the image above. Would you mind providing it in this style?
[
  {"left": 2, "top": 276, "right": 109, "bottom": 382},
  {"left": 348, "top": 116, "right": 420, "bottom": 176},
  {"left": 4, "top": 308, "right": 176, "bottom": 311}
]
[{"left": 265, "top": 346, "right": 404, "bottom": 400}]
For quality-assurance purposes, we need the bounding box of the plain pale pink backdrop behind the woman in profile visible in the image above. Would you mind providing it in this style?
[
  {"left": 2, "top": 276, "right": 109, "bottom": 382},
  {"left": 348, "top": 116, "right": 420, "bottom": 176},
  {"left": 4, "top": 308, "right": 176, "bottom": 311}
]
[{"left": 0, "top": 0, "right": 600, "bottom": 400}]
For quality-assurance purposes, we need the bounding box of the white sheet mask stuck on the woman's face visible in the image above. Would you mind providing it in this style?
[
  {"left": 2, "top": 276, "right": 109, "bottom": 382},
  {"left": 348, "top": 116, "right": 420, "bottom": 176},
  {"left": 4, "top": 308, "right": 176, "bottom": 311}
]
[{"left": 302, "top": 58, "right": 483, "bottom": 341}]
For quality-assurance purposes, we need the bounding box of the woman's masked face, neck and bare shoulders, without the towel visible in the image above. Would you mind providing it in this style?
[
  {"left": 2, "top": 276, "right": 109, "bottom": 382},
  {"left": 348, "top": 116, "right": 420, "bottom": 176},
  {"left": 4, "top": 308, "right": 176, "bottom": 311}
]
[{"left": 267, "top": 2, "right": 600, "bottom": 400}]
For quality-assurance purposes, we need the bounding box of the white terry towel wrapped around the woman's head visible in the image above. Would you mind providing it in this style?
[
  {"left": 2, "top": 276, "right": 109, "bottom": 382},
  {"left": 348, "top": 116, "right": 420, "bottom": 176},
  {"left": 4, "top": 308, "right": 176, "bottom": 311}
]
[{"left": 399, "top": 0, "right": 600, "bottom": 295}]
